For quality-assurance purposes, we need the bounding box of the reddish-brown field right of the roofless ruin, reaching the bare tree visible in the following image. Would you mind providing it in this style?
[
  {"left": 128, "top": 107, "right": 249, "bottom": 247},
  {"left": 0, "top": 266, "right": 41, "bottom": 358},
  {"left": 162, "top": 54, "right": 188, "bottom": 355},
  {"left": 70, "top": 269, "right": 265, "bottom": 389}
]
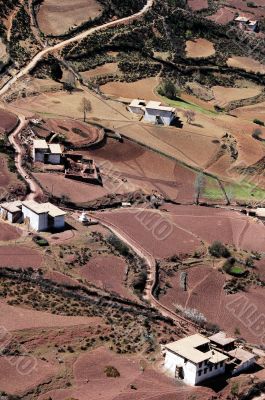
[{"left": 73, "top": 139, "right": 196, "bottom": 205}]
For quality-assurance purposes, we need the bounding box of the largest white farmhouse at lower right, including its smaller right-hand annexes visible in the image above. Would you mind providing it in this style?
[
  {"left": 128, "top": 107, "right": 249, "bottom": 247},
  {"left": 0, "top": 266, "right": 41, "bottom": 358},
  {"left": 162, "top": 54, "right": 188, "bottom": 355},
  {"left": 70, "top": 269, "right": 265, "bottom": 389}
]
[{"left": 162, "top": 332, "right": 256, "bottom": 385}]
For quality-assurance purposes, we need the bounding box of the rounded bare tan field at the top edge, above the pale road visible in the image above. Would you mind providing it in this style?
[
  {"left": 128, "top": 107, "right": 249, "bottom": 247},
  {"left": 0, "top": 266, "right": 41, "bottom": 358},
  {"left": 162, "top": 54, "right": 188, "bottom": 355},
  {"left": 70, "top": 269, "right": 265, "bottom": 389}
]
[{"left": 37, "top": 0, "right": 102, "bottom": 35}]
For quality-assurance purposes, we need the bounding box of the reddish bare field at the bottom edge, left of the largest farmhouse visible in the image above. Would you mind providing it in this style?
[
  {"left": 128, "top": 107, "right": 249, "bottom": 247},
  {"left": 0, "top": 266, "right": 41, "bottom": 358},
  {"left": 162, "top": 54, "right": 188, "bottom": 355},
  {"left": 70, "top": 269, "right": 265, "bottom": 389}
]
[{"left": 38, "top": 347, "right": 213, "bottom": 400}]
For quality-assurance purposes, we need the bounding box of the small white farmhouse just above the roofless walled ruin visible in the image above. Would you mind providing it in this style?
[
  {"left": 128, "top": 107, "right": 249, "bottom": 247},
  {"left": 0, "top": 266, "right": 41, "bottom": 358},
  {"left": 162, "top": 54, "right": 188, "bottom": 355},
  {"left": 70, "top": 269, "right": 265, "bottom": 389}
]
[{"left": 32, "top": 139, "right": 63, "bottom": 164}]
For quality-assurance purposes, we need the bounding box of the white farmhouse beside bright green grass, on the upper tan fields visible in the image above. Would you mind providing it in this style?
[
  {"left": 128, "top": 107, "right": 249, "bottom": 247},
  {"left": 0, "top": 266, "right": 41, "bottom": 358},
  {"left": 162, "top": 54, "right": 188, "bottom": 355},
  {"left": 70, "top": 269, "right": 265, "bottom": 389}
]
[{"left": 129, "top": 99, "right": 176, "bottom": 126}]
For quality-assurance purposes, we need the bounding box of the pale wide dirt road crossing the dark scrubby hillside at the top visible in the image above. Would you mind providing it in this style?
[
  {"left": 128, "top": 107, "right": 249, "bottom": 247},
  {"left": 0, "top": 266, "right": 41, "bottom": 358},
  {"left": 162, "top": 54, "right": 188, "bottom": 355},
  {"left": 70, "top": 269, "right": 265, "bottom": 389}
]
[{"left": 0, "top": 0, "right": 155, "bottom": 96}]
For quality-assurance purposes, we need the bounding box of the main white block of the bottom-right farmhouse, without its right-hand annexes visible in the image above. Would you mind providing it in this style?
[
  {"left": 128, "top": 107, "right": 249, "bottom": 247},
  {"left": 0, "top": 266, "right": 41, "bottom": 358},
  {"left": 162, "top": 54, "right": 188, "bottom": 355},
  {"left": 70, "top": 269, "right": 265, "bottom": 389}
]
[{"left": 163, "top": 334, "right": 228, "bottom": 385}]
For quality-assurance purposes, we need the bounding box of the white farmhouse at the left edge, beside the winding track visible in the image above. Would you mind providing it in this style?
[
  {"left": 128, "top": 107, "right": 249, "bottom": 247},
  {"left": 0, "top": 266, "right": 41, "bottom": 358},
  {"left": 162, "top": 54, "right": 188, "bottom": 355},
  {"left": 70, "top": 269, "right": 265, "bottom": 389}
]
[{"left": 0, "top": 200, "right": 66, "bottom": 231}]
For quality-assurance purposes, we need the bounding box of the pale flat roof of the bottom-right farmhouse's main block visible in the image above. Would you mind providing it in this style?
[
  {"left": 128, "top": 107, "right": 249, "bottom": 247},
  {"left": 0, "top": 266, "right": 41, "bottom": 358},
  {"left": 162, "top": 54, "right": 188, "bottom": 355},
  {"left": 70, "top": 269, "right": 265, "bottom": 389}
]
[{"left": 165, "top": 333, "right": 228, "bottom": 364}]
